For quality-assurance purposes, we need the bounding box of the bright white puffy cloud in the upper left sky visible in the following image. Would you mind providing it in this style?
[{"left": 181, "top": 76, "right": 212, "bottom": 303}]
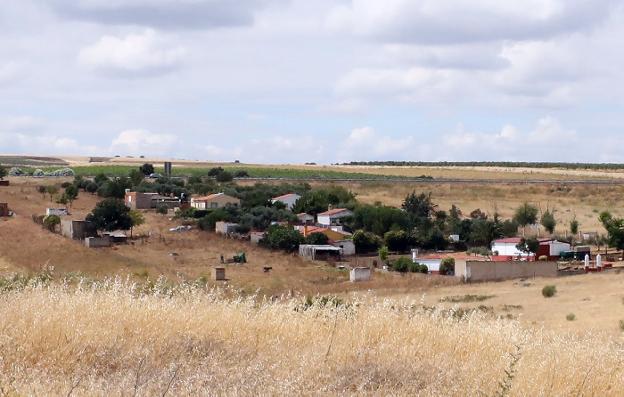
[{"left": 78, "top": 29, "right": 186, "bottom": 76}]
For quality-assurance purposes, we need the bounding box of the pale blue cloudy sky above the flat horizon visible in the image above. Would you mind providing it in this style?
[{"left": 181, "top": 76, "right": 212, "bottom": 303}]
[{"left": 0, "top": 0, "right": 624, "bottom": 164}]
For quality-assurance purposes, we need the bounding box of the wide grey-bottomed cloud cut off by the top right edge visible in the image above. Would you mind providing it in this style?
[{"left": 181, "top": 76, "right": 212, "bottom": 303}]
[{"left": 328, "top": 0, "right": 614, "bottom": 44}]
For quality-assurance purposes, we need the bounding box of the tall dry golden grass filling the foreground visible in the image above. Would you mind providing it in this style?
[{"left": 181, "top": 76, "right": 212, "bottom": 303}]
[{"left": 0, "top": 279, "right": 624, "bottom": 396}]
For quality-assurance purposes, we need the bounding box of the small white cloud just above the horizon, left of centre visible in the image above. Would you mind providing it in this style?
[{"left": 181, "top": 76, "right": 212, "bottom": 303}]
[{"left": 110, "top": 130, "right": 178, "bottom": 156}]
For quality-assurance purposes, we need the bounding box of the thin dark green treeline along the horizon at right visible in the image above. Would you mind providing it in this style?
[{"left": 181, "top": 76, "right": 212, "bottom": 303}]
[{"left": 342, "top": 161, "right": 624, "bottom": 170}]
